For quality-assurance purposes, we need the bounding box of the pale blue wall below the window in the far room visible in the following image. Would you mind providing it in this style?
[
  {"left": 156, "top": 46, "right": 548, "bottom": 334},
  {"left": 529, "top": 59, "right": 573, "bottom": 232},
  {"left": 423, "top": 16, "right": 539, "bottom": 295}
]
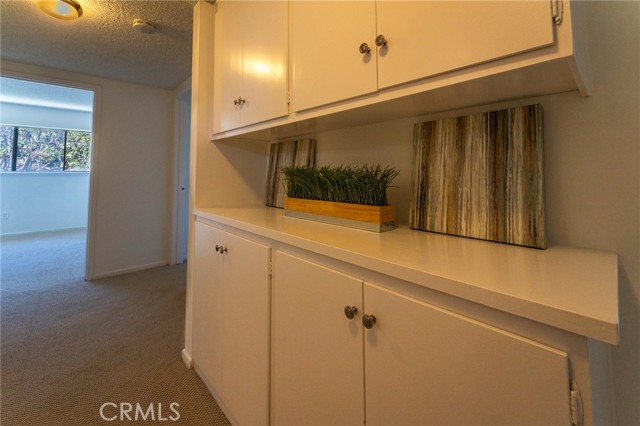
[{"left": 0, "top": 172, "right": 89, "bottom": 235}]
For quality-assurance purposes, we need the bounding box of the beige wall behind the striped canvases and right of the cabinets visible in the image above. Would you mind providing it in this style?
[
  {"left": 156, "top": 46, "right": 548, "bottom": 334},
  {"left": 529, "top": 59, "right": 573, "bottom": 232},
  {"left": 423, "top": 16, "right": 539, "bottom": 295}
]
[{"left": 316, "top": 2, "right": 640, "bottom": 426}]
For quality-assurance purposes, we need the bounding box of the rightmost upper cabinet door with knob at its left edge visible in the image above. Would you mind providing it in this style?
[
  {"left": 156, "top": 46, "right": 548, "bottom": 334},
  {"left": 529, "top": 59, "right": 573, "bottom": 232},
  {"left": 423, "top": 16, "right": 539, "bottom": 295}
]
[{"left": 377, "top": 0, "right": 554, "bottom": 89}]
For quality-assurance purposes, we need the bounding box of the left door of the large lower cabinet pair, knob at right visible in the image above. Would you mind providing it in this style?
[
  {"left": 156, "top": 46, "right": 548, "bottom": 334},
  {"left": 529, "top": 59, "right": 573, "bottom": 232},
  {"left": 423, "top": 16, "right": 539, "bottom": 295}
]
[{"left": 271, "top": 251, "right": 364, "bottom": 426}]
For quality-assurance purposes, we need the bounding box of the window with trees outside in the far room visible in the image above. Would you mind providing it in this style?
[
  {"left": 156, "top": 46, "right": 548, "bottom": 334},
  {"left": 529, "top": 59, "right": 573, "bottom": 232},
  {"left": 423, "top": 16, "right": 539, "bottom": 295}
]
[{"left": 0, "top": 126, "right": 91, "bottom": 172}]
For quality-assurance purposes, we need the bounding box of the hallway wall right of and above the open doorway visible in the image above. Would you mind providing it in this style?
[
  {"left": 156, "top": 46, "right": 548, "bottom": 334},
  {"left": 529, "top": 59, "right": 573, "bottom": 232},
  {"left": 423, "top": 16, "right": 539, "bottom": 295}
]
[{"left": 2, "top": 61, "right": 174, "bottom": 278}]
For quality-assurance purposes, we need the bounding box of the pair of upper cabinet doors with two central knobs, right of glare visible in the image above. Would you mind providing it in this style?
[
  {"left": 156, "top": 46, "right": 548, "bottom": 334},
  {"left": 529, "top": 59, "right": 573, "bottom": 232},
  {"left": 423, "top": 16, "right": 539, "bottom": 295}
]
[{"left": 290, "top": 0, "right": 555, "bottom": 111}]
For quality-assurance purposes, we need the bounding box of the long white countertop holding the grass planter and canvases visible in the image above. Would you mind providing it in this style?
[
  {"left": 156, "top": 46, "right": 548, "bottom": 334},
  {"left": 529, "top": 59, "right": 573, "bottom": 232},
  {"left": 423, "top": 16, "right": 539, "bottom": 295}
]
[{"left": 194, "top": 207, "right": 619, "bottom": 345}]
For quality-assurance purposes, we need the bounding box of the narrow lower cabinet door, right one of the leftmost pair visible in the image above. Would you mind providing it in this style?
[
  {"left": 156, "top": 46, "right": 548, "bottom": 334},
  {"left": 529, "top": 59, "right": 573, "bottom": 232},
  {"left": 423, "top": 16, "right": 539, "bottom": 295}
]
[{"left": 219, "top": 232, "right": 271, "bottom": 426}]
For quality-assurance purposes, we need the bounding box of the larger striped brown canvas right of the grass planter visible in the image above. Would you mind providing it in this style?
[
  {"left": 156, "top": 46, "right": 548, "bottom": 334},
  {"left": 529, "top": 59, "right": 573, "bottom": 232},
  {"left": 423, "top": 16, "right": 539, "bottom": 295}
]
[{"left": 409, "top": 105, "right": 546, "bottom": 248}]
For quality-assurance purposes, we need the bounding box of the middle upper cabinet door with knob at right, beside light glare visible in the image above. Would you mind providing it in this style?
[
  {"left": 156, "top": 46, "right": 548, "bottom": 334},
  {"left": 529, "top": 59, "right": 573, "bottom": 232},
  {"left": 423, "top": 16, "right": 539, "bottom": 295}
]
[{"left": 290, "top": 1, "right": 377, "bottom": 111}]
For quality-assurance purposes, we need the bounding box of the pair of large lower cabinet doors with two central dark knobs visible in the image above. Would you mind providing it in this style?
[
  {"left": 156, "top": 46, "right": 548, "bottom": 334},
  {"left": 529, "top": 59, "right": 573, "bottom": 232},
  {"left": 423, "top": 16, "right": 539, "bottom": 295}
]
[{"left": 271, "top": 251, "right": 570, "bottom": 425}]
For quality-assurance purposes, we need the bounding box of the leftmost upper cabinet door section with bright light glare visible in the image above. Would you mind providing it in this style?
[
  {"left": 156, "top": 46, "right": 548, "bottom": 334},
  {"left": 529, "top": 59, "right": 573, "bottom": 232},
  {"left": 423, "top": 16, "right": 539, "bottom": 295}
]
[{"left": 213, "top": 0, "right": 288, "bottom": 133}]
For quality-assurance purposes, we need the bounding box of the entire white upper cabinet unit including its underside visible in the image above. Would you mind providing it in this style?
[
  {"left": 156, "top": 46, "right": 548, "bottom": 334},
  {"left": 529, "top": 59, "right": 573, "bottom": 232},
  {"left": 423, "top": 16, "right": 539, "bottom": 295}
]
[{"left": 212, "top": 0, "right": 590, "bottom": 141}]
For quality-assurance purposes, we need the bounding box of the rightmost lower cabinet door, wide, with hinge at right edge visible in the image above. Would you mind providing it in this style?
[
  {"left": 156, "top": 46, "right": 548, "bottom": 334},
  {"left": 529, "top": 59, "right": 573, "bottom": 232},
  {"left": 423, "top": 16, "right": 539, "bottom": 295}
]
[{"left": 364, "top": 283, "right": 571, "bottom": 426}]
